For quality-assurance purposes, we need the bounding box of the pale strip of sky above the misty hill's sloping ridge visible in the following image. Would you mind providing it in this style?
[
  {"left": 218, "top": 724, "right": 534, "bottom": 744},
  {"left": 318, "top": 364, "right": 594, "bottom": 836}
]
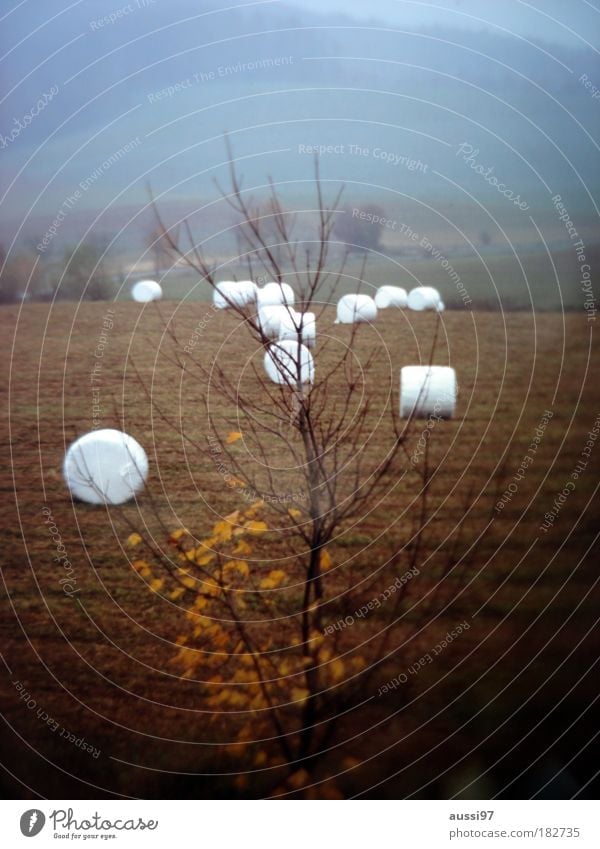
[{"left": 292, "top": 0, "right": 600, "bottom": 46}]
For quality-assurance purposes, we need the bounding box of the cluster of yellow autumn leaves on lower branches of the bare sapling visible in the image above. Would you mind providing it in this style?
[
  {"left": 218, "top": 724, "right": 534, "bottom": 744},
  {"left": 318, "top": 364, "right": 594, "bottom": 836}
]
[{"left": 128, "top": 500, "right": 368, "bottom": 790}]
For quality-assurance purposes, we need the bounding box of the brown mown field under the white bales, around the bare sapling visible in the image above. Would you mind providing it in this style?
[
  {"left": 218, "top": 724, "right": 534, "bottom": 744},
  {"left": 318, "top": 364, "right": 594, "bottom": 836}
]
[{"left": 0, "top": 301, "right": 600, "bottom": 798}]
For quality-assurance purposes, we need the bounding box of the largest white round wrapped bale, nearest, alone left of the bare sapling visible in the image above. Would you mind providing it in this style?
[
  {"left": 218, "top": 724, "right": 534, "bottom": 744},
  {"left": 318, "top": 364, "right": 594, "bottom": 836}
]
[{"left": 63, "top": 428, "right": 148, "bottom": 504}]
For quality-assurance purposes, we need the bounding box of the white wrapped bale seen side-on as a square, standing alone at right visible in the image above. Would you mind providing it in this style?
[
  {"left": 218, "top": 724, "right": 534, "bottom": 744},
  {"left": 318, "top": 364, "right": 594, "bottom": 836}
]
[{"left": 400, "top": 366, "right": 456, "bottom": 419}]
